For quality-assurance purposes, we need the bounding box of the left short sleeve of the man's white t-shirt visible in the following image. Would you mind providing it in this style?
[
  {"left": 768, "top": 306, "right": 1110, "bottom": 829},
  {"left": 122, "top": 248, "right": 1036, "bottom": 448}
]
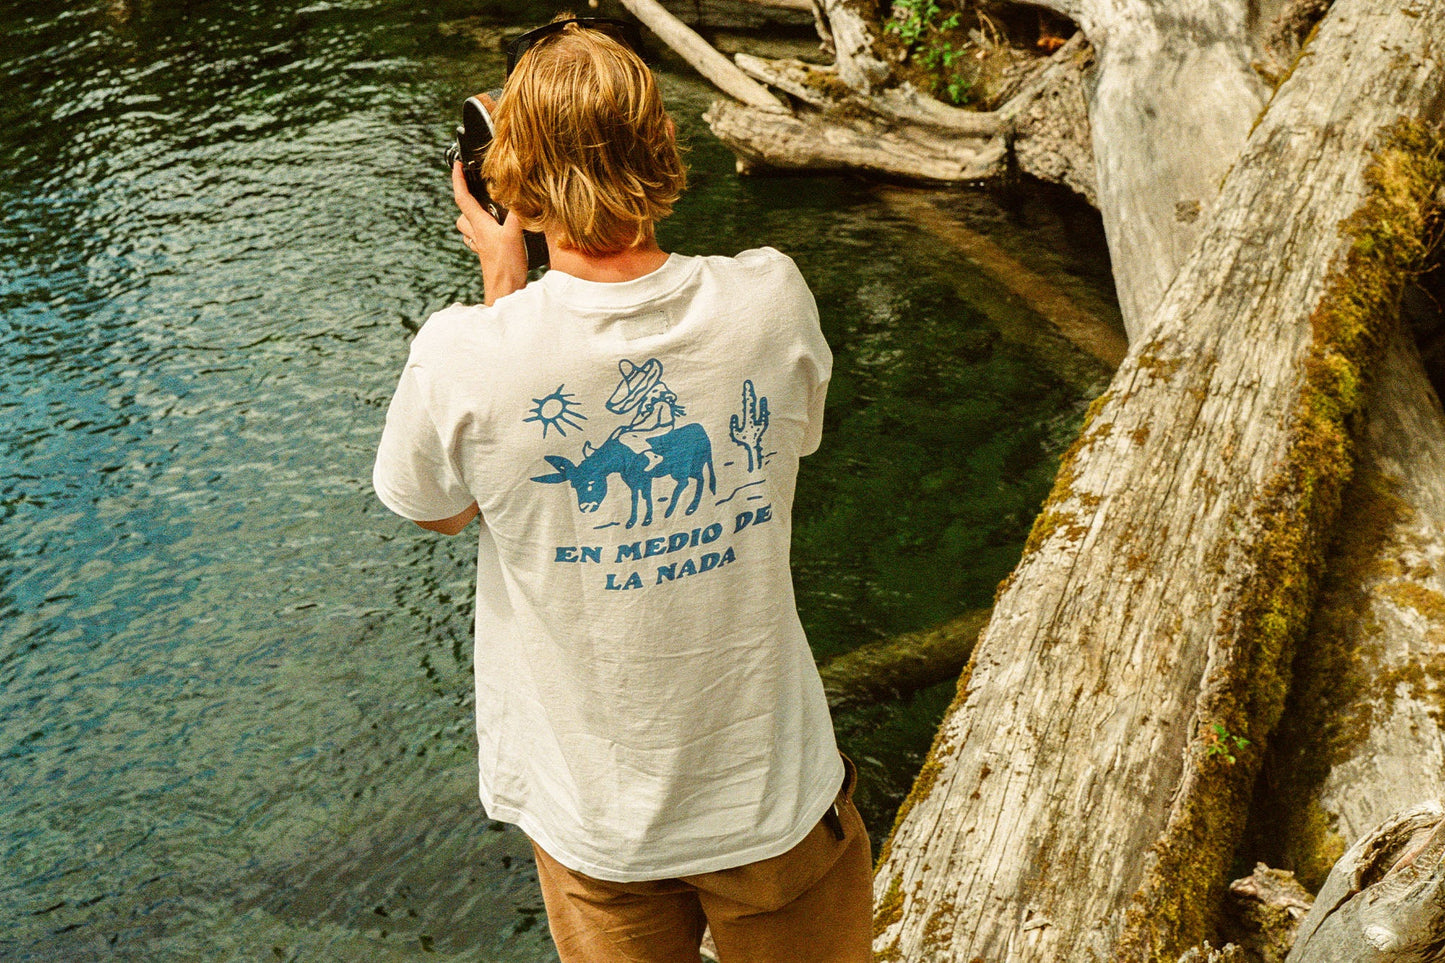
[{"left": 371, "top": 363, "right": 475, "bottom": 522}]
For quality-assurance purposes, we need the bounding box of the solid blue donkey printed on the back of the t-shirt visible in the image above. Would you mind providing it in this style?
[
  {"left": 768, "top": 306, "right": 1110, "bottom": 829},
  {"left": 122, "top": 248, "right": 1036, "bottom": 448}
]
[{"left": 532, "top": 422, "right": 718, "bottom": 528}]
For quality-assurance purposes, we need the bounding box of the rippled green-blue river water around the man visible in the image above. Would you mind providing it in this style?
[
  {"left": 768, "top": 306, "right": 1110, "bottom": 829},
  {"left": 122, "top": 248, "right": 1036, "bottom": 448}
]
[{"left": 0, "top": 0, "right": 1114, "bottom": 963}]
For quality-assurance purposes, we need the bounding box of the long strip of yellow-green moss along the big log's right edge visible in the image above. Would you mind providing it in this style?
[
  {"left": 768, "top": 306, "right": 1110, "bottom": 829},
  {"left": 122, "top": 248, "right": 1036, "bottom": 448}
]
[{"left": 1117, "top": 124, "right": 1445, "bottom": 963}]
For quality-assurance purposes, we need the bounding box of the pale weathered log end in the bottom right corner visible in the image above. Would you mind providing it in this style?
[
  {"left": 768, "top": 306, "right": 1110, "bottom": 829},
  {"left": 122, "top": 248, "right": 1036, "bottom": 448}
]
[{"left": 1287, "top": 803, "right": 1445, "bottom": 963}]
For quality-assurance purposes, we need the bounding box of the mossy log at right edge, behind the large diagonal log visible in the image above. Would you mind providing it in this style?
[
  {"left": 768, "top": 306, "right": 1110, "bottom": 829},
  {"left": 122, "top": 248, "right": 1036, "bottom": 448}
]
[{"left": 1253, "top": 323, "right": 1445, "bottom": 888}]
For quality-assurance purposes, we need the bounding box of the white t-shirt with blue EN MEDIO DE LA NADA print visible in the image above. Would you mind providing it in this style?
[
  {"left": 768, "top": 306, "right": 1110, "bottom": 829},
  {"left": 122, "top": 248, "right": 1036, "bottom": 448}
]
[{"left": 373, "top": 247, "right": 842, "bottom": 882}]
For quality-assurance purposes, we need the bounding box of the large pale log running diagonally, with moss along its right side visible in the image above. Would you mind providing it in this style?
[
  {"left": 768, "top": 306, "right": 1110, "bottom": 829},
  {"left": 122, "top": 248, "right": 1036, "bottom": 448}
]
[{"left": 876, "top": 0, "right": 1445, "bottom": 962}]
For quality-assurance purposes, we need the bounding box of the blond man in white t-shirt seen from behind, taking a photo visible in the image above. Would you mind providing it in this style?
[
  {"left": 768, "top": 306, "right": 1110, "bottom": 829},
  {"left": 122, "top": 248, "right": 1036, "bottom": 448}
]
[{"left": 374, "top": 20, "right": 871, "bottom": 963}]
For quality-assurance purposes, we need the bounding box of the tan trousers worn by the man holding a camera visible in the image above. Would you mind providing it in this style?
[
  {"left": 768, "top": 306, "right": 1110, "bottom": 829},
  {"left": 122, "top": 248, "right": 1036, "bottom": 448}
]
[{"left": 532, "top": 761, "right": 873, "bottom": 963}]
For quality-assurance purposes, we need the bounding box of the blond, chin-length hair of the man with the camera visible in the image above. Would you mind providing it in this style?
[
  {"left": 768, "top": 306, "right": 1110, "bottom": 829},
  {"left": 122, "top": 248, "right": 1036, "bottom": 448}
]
[{"left": 483, "top": 25, "right": 686, "bottom": 256}]
